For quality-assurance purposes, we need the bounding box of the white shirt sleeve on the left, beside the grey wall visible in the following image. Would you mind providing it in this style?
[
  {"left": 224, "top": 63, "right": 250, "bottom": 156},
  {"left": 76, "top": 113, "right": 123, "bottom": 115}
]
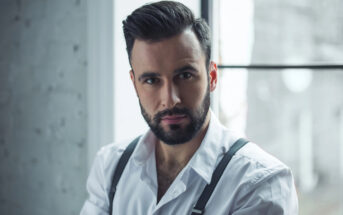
[{"left": 80, "top": 154, "right": 109, "bottom": 215}]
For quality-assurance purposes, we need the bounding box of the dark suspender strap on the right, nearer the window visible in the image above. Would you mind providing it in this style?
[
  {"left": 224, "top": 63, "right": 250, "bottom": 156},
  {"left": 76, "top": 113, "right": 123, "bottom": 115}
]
[{"left": 191, "top": 138, "right": 249, "bottom": 215}]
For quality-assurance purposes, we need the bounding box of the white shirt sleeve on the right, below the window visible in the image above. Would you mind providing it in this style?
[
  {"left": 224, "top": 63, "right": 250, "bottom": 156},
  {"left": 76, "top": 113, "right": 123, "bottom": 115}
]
[{"left": 230, "top": 168, "right": 298, "bottom": 215}]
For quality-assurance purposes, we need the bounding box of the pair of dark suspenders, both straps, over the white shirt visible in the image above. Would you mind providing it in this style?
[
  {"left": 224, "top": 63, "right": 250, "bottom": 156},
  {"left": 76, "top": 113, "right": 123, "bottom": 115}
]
[{"left": 109, "top": 136, "right": 249, "bottom": 215}]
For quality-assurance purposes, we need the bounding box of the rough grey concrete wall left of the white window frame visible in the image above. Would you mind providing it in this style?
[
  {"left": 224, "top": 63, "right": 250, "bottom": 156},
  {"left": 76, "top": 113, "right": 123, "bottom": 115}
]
[{"left": 0, "top": 0, "right": 87, "bottom": 215}]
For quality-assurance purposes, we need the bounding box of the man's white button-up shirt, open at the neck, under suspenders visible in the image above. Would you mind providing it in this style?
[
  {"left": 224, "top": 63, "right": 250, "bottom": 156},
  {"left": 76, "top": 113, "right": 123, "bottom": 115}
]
[{"left": 81, "top": 113, "right": 298, "bottom": 215}]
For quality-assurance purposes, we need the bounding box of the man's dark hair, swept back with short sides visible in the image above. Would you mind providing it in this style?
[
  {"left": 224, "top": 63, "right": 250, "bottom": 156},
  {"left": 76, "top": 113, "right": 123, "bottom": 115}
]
[{"left": 123, "top": 1, "right": 211, "bottom": 66}]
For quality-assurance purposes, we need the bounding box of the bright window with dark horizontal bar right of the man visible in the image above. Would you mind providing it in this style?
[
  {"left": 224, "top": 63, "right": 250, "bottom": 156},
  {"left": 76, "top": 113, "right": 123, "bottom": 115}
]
[{"left": 209, "top": 0, "right": 343, "bottom": 215}]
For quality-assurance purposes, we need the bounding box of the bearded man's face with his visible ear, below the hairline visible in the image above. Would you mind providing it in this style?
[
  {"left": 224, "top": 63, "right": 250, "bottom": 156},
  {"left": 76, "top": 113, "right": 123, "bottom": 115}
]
[{"left": 130, "top": 30, "right": 217, "bottom": 145}]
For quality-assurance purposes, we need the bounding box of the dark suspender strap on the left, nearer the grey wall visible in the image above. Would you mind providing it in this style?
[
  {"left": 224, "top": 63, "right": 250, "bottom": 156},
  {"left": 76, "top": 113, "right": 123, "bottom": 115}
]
[{"left": 109, "top": 136, "right": 140, "bottom": 214}]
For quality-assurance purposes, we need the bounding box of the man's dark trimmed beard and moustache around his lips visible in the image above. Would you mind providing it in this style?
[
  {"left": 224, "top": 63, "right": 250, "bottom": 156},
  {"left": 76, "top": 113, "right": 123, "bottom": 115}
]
[{"left": 139, "top": 84, "right": 210, "bottom": 145}]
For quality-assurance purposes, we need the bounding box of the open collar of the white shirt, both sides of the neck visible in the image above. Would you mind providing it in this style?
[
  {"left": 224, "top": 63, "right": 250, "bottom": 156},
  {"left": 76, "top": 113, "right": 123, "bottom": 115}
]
[{"left": 132, "top": 110, "right": 232, "bottom": 184}]
